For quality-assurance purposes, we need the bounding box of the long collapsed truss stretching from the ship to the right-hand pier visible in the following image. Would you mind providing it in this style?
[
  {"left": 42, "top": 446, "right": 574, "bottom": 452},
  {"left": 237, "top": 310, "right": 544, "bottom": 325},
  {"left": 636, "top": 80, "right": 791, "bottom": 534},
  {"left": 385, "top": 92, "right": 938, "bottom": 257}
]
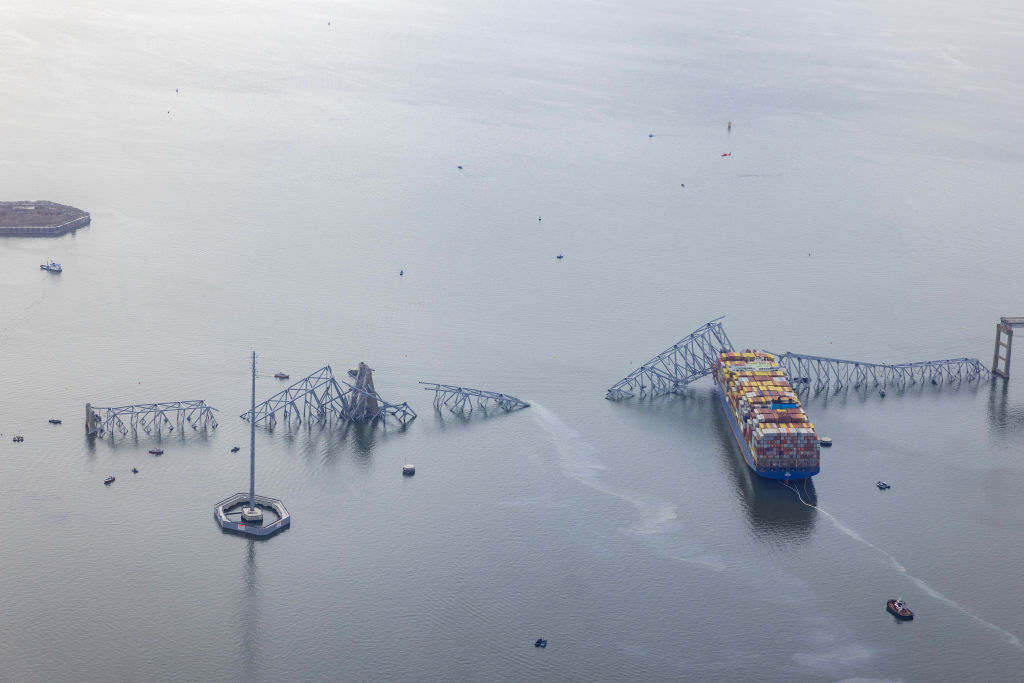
[{"left": 775, "top": 351, "right": 991, "bottom": 390}]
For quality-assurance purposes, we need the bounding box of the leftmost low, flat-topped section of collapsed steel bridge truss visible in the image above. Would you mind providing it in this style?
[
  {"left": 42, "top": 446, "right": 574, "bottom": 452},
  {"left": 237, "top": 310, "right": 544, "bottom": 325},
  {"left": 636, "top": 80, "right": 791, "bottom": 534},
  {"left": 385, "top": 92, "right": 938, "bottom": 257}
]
[{"left": 85, "top": 400, "right": 217, "bottom": 436}]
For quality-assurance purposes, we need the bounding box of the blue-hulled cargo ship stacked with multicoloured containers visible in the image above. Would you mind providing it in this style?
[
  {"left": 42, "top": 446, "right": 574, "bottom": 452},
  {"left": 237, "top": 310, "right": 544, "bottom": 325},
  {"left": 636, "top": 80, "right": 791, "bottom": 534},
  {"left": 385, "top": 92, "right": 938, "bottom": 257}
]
[{"left": 714, "top": 350, "right": 820, "bottom": 480}]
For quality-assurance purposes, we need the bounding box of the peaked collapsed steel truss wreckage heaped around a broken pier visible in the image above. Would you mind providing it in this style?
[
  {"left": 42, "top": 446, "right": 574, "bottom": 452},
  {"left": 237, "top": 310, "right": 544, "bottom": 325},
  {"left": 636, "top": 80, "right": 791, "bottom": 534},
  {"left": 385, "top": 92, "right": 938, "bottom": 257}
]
[{"left": 241, "top": 362, "right": 416, "bottom": 428}]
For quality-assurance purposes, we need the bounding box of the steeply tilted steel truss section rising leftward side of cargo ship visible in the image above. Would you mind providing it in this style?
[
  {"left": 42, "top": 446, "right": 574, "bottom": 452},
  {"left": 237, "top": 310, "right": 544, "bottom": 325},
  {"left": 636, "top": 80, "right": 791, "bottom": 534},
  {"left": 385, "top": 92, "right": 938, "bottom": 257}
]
[{"left": 604, "top": 317, "right": 732, "bottom": 400}]
